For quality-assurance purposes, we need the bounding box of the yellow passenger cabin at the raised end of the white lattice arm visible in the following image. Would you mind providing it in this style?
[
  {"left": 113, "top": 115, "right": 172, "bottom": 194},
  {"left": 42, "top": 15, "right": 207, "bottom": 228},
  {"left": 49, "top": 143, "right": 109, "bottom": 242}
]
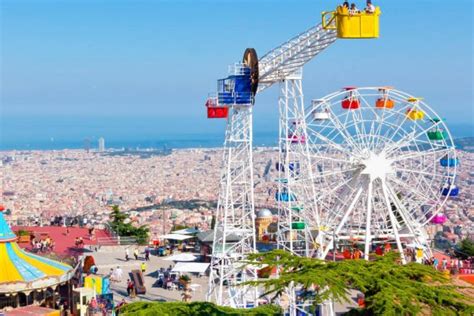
[{"left": 322, "top": 6, "right": 381, "bottom": 38}]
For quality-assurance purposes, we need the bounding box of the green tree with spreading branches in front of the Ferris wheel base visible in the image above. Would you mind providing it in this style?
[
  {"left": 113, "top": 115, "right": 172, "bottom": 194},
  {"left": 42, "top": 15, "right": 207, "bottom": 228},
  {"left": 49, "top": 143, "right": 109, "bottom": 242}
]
[{"left": 248, "top": 250, "right": 474, "bottom": 315}]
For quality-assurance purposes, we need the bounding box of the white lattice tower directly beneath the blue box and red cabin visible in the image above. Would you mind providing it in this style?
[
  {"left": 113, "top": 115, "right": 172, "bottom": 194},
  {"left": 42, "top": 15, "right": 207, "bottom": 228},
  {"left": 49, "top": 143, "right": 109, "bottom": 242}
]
[{"left": 206, "top": 105, "right": 258, "bottom": 308}]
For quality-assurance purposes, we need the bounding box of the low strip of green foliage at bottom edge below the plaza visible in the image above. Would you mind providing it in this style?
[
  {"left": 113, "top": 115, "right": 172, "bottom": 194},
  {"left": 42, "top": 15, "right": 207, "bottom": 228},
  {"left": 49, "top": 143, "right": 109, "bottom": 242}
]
[{"left": 120, "top": 302, "right": 282, "bottom": 316}]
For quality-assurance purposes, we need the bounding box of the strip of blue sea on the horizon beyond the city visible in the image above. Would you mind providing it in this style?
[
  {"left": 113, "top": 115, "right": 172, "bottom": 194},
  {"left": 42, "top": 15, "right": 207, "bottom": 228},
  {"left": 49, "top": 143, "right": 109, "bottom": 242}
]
[{"left": 0, "top": 118, "right": 474, "bottom": 151}]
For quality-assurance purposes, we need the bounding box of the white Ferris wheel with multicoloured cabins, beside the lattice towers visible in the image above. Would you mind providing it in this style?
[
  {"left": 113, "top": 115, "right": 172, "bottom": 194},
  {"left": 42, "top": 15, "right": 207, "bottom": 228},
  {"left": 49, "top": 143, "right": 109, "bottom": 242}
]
[{"left": 305, "top": 87, "right": 459, "bottom": 262}]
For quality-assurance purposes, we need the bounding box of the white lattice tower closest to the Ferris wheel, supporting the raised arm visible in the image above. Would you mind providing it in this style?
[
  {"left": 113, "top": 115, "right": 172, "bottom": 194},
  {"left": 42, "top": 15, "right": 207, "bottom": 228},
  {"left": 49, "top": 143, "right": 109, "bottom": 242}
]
[{"left": 277, "top": 73, "right": 334, "bottom": 316}]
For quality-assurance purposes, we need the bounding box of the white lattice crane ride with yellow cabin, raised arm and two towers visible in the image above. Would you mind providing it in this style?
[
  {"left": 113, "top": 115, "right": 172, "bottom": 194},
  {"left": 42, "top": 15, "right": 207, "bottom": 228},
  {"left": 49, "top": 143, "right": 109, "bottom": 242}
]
[{"left": 206, "top": 8, "right": 380, "bottom": 315}]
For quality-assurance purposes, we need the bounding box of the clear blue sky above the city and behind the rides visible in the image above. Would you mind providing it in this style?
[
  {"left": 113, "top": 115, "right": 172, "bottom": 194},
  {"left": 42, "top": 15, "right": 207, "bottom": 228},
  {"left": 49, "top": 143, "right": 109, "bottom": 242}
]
[{"left": 0, "top": 0, "right": 474, "bottom": 146}]
